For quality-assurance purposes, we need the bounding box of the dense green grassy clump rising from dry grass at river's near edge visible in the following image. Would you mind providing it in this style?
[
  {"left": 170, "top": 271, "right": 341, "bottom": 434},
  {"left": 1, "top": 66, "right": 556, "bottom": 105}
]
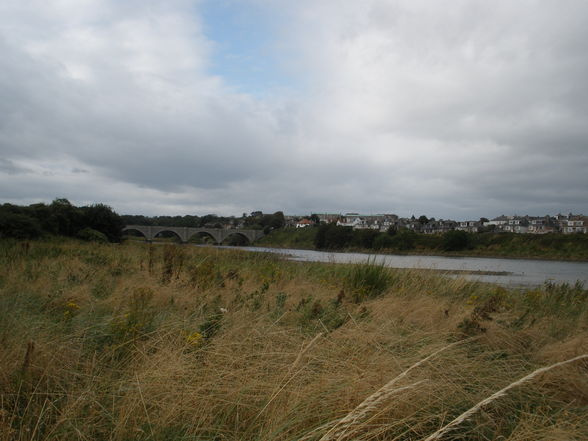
[{"left": 345, "top": 259, "right": 393, "bottom": 303}]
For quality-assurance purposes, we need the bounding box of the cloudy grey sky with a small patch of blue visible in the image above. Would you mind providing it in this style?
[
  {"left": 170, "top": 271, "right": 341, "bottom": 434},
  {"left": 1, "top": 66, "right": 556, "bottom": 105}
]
[{"left": 0, "top": 0, "right": 588, "bottom": 219}]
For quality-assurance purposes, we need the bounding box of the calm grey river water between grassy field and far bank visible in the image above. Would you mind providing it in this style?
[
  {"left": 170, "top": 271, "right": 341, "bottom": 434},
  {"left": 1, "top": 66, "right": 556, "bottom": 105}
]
[{"left": 224, "top": 247, "right": 588, "bottom": 286}]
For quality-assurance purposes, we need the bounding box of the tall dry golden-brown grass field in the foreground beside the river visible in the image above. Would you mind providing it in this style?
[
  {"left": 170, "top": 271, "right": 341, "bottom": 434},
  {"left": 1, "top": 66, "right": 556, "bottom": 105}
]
[{"left": 0, "top": 239, "right": 588, "bottom": 441}]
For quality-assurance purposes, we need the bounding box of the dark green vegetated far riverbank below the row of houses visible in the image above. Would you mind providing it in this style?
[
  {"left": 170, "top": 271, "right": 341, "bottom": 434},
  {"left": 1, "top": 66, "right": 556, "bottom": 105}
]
[{"left": 256, "top": 224, "right": 588, "bottom": 260}]
